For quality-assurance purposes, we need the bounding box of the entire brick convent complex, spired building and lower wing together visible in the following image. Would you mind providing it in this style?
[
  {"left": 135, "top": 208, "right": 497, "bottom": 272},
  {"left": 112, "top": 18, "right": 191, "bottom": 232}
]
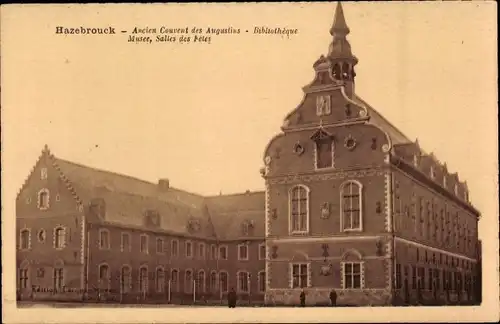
[{"left": 16, "top": 3, "right": 480, "bottom": 305}]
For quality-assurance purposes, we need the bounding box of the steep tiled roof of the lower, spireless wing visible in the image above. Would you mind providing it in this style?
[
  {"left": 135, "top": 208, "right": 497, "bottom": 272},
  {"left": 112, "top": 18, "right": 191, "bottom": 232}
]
[{"left": 52, "top": 156, "right": 265, "bottom": 239}]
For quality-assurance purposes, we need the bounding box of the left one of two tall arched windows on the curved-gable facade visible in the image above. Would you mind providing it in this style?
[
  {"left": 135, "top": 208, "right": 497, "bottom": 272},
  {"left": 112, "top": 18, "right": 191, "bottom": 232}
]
[{"left": 289, "top": 185, "right": 309, "bottom": 233}]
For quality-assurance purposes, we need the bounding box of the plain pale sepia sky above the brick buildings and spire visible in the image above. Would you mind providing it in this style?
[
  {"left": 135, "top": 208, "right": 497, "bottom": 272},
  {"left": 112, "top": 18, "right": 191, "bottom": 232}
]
[{"left": 1, "top": 2, "right": 498, "bottom": 320}]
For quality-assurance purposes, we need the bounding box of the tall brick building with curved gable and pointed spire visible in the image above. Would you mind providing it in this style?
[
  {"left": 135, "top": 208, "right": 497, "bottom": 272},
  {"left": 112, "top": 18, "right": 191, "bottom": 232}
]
[{"left": 263, "top": 3, "right": 479, "bottom": 305}]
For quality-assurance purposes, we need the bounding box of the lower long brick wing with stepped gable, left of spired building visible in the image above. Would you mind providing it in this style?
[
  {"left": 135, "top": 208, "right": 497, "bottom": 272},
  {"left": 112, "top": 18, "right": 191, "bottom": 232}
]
[{"left": 17, "top": 148, "right": 265, "bottom": 303}]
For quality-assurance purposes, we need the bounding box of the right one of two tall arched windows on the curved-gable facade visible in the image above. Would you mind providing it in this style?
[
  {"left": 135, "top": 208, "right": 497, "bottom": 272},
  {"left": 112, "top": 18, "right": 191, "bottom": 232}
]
[{"left": 340, "top": 181, "right": 363, "bottom": 231}]
